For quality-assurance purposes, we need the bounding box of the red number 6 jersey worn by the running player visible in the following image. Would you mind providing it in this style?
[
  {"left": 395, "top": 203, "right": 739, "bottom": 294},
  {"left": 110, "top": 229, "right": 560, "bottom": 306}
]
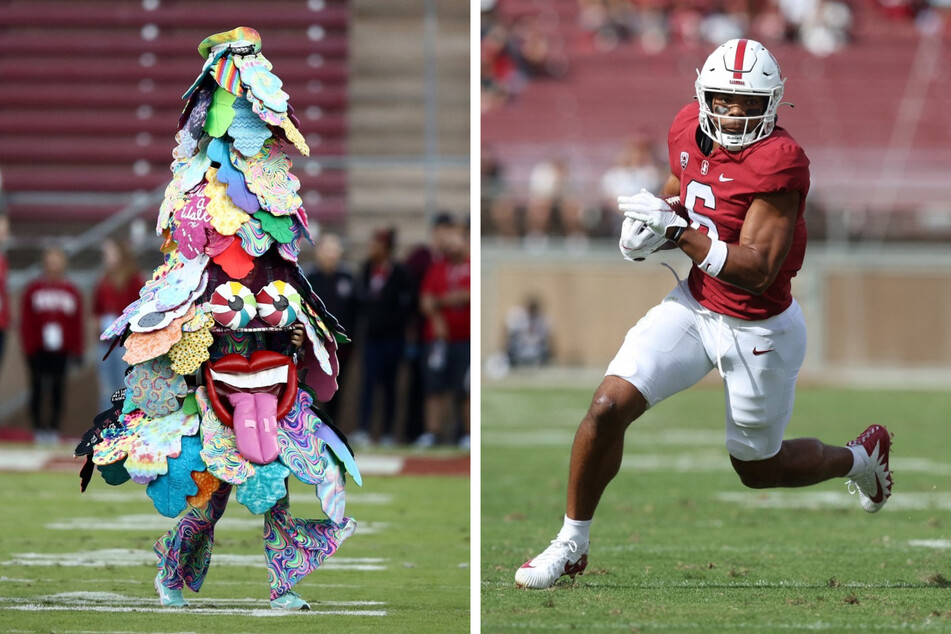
[{"left": 667, "top": 102, "right": 809, "bottom": 320}]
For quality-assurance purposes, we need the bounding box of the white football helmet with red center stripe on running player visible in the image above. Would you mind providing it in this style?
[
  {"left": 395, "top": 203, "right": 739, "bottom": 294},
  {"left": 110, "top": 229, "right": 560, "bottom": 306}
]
[{"left": 696, "top": 39, "right": 786, "bottom": 151}]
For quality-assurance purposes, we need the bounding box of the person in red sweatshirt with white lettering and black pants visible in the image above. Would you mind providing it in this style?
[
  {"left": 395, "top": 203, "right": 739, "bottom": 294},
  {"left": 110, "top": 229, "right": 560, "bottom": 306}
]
[{"left": 20, "top": 248, "right": 84, "bottom": 443}]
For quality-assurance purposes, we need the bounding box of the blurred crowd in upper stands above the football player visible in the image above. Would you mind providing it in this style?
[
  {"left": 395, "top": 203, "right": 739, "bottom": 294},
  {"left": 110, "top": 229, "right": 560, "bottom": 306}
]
[{"left": 488, "top": 0, "right": 951, "bottom": 112}]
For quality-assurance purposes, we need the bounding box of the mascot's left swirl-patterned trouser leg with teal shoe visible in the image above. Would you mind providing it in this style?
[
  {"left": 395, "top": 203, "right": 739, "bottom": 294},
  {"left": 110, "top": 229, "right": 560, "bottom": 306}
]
[{"left": 155, "top": 484, "right": 231, "bottom": 607}]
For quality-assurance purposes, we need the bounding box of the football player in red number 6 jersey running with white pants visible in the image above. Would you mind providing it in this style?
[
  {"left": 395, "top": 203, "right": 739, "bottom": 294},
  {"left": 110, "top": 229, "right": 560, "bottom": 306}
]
[{"left": 515, "top": 39, "right": 892, "bottom": 588}]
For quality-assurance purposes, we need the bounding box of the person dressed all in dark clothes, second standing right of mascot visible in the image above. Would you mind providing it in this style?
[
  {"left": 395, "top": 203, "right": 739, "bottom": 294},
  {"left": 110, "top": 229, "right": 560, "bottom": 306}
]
[{"left": 350, "top": 229, "right": 413, "bottom": 445}]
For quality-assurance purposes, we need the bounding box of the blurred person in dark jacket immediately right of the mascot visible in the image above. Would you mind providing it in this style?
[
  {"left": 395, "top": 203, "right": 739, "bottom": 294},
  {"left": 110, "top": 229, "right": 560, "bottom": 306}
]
[{"left": 307, "top": 233, "right": 359, "bottom": 420}]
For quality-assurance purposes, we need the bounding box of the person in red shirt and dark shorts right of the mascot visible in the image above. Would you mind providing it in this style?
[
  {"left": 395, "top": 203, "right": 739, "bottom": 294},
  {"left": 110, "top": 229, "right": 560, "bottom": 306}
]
[{"left": 415, "top": 220, "right": 470, "bottom": 448}]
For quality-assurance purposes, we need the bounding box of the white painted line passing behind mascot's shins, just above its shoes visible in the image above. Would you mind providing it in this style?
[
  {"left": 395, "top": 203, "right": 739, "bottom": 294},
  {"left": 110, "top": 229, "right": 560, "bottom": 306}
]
[{"left": 0, "top": 548, "right": 388, "bottom": 571}]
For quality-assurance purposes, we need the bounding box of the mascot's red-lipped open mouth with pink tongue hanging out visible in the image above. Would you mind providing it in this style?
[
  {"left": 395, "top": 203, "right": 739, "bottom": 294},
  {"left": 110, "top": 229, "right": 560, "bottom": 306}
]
[{"left": 205, "top": 350, "right": 297, "bottom": 464}]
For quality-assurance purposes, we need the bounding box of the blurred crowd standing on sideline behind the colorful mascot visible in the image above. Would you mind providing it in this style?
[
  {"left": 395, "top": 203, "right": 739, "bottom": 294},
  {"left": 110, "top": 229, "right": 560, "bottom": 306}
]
[{"left": 0, "top": 205, "right": 470, "bottom": 449}]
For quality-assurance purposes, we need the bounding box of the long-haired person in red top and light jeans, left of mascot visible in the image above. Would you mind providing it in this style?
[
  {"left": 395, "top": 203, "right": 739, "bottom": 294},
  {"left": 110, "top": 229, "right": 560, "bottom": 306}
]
[{"left": 92, "top": 238, "right": 145, "bottom": 411}]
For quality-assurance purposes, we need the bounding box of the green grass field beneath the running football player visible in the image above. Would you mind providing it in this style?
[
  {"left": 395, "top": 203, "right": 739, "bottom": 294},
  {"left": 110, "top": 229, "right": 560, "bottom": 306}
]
[{"left": 481, "top": 386, "right": 951, "bottom": 632}]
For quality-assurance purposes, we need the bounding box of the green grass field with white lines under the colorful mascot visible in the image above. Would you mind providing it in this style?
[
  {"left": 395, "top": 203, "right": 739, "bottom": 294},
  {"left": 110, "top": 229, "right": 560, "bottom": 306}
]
[{"left": 0, "top": 450, "right": 470, "bottom": 634}]
